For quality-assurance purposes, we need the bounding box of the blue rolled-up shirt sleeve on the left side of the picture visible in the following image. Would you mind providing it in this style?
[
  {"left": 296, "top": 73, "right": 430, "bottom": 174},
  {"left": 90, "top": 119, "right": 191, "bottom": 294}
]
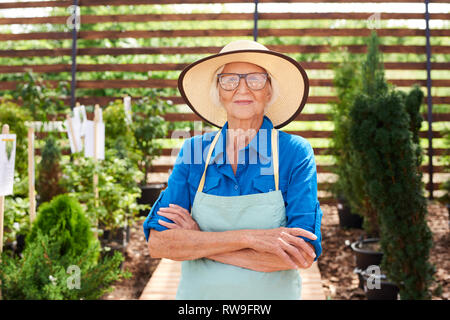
[{"left": 144, "top": 139, "right": 190, "bottom": 241}]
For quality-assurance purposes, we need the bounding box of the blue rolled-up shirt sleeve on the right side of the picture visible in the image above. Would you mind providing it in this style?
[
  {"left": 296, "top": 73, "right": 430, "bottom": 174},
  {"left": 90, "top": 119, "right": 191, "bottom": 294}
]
[{"left": 286, "top": 143, "right": 323, "bottom": 261}]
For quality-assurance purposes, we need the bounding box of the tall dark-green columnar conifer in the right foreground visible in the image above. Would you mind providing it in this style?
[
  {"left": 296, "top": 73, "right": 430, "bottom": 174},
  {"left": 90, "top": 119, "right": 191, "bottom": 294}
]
[{"left": 350, "top": 32, "right": 433, "bottom": 299}]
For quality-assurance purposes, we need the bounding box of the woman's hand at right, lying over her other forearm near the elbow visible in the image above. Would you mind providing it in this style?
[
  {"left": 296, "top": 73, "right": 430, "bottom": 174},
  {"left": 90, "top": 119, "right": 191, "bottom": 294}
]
[{"left": 246, "top": 228, "right": 317, "bottom": 269}]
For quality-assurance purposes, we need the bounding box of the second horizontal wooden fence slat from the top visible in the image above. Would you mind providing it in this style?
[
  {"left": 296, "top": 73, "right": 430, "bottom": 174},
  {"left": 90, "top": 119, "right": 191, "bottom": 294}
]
[{"left": 0, "top": 12, "right": 450, "bottom": 24}]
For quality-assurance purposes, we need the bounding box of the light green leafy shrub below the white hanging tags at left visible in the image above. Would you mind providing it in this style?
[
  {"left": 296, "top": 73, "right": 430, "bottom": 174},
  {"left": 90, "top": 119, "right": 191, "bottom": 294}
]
[{"left": 61, "top": 149, "right": 146, "bottom": 234}]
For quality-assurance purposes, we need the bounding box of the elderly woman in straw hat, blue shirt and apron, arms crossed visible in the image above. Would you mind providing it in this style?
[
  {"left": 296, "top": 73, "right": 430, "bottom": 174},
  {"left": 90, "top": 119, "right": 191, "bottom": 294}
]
[{"left": 144, "top": 40, "right": 322, "bottom": 299}]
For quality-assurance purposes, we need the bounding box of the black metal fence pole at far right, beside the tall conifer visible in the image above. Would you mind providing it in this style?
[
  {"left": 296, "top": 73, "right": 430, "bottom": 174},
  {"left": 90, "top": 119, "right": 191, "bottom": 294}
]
[{"left": 425, "top": 0, "right": 434, "bottom": 200}]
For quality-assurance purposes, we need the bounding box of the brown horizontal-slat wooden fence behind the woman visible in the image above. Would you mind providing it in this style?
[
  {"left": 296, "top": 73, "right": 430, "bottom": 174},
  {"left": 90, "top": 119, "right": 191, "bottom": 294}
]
[{"left": 0, "top": 0, "right": 450, "bottom": 203}]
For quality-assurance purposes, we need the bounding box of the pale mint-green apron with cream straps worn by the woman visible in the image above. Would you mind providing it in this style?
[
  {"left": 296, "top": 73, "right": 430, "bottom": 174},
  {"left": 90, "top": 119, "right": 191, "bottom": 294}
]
[{"left": 176, "top": 129, "right": 301, "bottom": 300}]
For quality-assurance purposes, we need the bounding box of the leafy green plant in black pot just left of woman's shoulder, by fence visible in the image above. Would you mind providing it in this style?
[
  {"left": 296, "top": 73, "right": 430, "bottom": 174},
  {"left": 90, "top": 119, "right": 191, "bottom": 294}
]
[{"left": 131, "top": 91, "right": 172, "bottom": 215}]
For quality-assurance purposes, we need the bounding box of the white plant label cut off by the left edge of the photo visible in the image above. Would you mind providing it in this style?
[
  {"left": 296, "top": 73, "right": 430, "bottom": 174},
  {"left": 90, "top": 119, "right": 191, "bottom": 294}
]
[{"left": 0, "top": 134, "right": 16, "bottom": 196}]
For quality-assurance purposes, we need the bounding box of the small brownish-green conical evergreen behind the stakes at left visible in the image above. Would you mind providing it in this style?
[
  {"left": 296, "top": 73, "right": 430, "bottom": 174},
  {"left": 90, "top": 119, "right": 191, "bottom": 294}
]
[{"left": 36, "top": 134, "right": 65, "bottom": 202}]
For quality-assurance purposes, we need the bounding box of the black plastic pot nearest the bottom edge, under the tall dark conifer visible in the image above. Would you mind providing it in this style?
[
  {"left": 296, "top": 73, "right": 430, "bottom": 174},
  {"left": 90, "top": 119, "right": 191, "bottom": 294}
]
[{"left": 361, "top": 270, "right": 400, "bottom": 300}]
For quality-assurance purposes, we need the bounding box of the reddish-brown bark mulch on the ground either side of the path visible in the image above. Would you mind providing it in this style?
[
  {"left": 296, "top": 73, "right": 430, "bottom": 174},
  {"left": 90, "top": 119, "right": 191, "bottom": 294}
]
[{"left": 102, "top": 202, "right": 450, "bottom": 300}]
